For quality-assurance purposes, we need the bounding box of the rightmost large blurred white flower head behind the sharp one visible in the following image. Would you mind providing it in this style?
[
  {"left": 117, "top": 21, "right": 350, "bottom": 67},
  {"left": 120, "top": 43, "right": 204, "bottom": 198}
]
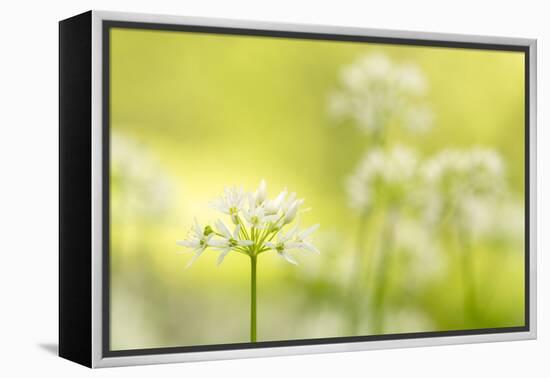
[{"left": 422, "top": 147, "right": 507, "bottom": 229}]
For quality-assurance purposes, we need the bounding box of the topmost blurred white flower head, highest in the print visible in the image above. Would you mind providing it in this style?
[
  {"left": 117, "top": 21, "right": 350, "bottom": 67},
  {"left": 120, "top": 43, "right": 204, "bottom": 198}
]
[{"left": 328, "top": 54, "right": 433, "bottom": 134}]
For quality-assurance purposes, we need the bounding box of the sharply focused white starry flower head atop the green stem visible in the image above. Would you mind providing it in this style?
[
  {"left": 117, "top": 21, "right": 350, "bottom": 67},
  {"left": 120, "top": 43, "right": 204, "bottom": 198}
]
[{"left": 177, "top": 180, "right": 319, "bottom": 266}]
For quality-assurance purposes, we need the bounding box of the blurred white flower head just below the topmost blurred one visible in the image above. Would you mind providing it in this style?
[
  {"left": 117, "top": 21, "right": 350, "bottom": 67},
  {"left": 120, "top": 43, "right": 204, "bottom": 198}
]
[{"left": 346, "top": 145, "right": 418, "bottom": 211}]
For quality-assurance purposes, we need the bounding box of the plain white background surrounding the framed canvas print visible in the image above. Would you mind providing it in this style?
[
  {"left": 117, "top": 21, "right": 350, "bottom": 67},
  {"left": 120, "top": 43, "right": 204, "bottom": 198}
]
[{"left": 0, "top": 0, "right": 550, "bottom": 378}]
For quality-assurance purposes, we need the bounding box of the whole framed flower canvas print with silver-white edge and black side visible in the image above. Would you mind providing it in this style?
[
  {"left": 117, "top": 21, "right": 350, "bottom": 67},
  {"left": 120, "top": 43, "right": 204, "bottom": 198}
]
[{"left": 59, "top": 11, "right": 536, "bottom": 367}]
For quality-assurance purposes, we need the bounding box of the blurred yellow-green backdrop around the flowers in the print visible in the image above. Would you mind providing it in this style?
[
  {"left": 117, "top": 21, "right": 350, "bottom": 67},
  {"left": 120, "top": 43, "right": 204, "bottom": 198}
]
[{"left": 110, "top": 28, "right": 525, "bottom": 350}]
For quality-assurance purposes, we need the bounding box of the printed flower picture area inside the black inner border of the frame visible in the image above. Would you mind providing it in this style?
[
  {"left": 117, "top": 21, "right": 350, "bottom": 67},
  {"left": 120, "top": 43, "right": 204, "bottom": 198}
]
[{"left": 107, "top": 27, "right": 526, "bottom": 351}]
